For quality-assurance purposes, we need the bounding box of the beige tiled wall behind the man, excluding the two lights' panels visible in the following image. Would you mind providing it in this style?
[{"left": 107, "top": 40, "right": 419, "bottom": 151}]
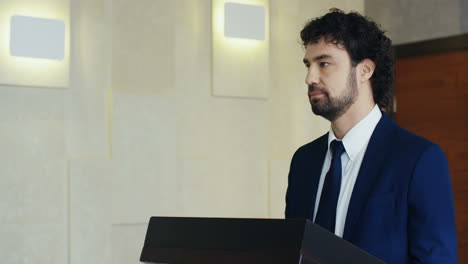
[{"left": 0, "top": 0, "right": 364, "bottom": 264}]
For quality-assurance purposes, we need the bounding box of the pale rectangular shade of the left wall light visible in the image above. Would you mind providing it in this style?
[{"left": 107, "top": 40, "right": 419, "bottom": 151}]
[{"left": 10, "top": 15, "right": 65, "bottom": 60}]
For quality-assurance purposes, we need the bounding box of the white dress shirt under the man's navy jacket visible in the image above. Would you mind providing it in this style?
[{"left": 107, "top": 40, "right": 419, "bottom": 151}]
[{"left": 314, "top": 105, "right": 382, "bottom": 237}]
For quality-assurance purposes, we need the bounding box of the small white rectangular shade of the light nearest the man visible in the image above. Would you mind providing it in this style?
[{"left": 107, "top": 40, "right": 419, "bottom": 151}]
[{"left": 224, "top": 3, "right": 265, "bottom": 40}]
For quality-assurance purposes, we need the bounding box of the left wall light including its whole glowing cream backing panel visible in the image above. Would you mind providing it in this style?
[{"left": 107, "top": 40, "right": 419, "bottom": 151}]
[{"left": 0, "top": 0, "right": 71, "bottom": 88}]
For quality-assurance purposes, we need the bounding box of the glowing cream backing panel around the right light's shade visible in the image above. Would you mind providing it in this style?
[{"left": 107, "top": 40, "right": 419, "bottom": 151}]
[{"left": 212, "top": 0, "right": 270, "bottom": 99}]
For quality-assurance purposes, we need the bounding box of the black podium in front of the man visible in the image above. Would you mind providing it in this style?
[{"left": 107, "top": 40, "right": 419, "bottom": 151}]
[{"left": 140, "top": 217, "right": 384, "bottom": 264}]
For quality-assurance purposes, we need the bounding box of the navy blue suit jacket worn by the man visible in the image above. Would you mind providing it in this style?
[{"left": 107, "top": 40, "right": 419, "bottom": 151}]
[{"left": 286, "top": 114, "right": 457, "bottom": 264}]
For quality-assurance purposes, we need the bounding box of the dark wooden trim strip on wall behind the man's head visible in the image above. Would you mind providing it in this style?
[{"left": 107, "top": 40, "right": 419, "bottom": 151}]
[{"left": 393, "top": 34, "right": 468, "bottom": 59}]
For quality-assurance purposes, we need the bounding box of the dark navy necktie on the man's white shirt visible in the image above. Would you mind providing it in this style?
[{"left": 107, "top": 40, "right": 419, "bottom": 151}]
[{"left": 315, "top": 140, "right": 345, "bottom": 233}]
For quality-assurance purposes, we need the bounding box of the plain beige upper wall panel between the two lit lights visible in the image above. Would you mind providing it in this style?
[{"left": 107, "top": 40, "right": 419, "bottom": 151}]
[{"left": 112, "top": 0, "right": 174, "bottom": 94}]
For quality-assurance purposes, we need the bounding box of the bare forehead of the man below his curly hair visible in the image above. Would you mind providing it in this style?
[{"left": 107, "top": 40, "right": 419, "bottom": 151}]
[{"left": 304, "top": 39, "right": 350, "bottom": 61}]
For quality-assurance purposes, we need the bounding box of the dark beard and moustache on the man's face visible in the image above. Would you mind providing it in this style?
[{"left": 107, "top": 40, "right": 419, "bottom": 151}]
[{"left": 309, "top": 67, "right": 359, "bottom": 122}]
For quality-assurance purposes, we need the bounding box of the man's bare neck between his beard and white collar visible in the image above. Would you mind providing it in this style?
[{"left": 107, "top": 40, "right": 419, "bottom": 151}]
[{"left": 331, "top": 99, "right": 375, "bottom": 139}]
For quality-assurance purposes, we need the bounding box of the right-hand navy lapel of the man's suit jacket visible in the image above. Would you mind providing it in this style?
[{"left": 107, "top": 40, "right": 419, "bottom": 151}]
[{"left": 343, "top": 113, "right": 395, "bottom": 240}]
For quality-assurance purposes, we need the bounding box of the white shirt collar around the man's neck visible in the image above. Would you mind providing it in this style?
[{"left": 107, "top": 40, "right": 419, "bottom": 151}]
[{"left": 328, "top": 105, "right": 382, "bottom": 160}]
